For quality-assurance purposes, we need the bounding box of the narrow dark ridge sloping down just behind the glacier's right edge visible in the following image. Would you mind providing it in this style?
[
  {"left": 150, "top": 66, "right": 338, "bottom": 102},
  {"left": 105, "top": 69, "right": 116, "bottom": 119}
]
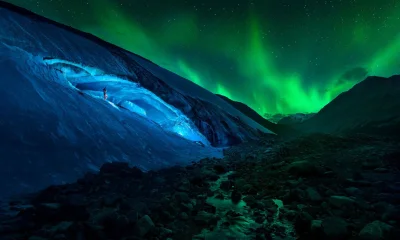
[{"left": 216, "top": 94, "right": 299, "bottom": 136}]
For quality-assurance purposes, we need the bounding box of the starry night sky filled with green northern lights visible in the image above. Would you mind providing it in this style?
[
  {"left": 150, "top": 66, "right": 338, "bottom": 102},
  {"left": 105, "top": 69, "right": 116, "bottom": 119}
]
[{"left": 8, "top": 0, "right": 400, "bottom": 114}]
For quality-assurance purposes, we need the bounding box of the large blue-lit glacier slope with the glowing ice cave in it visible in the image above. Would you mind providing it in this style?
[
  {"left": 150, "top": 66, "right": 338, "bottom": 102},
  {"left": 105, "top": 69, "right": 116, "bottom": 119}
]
[{"left": 0, "top": 2, "right": 273, "bottom": 196}]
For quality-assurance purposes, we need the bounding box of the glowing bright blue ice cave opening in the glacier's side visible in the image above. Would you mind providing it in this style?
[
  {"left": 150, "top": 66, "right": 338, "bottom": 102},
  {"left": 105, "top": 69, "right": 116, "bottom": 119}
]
[{"left": 43, "top": 57, "right": 210, "bottom": 146}]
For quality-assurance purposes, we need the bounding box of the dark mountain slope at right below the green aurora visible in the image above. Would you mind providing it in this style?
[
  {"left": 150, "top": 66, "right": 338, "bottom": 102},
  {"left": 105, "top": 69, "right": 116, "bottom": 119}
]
[{"left": 298, "top": 75, "right": 400, "bottom": 135}]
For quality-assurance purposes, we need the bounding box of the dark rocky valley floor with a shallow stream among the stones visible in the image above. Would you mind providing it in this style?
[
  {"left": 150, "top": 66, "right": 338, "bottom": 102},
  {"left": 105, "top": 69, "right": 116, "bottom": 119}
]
[{"left": 0, "top": 135, "right": 400, "bottom": 240}]
